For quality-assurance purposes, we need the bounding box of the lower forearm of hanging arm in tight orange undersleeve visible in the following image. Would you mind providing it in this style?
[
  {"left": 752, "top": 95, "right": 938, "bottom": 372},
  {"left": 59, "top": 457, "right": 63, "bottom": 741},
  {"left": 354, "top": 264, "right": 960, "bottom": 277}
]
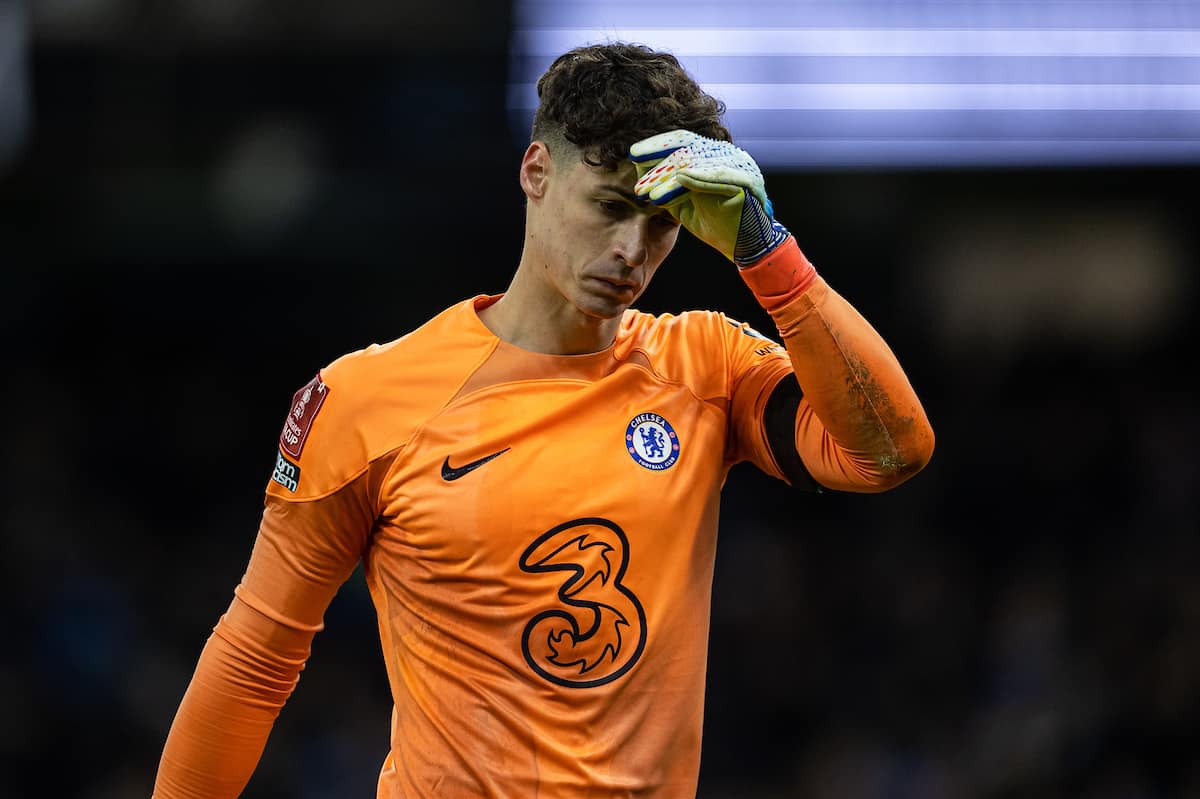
[{"left": 154, "top": 599, "right": 313, "bottom": 799}]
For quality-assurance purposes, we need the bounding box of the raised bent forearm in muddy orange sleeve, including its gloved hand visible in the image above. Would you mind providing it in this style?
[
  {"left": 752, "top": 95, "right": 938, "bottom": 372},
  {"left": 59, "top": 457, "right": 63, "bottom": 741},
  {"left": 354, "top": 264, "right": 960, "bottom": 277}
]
[{"left": 629, "top": 130, "right": 934, "bottom": 491}]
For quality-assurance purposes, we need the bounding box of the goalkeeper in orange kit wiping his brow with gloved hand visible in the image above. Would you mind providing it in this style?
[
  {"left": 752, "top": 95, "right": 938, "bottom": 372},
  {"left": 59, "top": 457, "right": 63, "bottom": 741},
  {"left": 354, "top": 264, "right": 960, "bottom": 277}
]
[{"left": 155, "top": 43, "right": 934, "bottom": 799}]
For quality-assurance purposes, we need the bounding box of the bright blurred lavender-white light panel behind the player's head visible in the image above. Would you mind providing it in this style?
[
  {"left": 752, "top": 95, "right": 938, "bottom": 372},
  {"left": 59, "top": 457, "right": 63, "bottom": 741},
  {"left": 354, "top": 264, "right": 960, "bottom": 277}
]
[{"left": 509, "top": 0, "right": 1200, "bottom": 168}]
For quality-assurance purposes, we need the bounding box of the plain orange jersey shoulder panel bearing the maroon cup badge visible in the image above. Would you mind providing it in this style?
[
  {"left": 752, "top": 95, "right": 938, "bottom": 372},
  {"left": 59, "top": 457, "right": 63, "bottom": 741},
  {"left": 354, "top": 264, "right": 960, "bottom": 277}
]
[{"left": 269, "top": 300, "right": 496, "bottom": 499}]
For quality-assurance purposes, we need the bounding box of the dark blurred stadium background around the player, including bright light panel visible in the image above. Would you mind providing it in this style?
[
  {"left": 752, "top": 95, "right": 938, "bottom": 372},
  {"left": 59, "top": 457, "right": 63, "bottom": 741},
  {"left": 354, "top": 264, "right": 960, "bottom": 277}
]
[{"left": 0, "top": 0, "right": 1200, "bottom": 799}]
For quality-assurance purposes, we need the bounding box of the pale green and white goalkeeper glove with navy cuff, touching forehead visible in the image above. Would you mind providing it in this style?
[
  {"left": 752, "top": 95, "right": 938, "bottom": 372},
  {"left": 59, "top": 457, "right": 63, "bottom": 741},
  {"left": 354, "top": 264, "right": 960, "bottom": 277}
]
[{"left": 629, "top": 130, "right": 790, "bottom": 268}]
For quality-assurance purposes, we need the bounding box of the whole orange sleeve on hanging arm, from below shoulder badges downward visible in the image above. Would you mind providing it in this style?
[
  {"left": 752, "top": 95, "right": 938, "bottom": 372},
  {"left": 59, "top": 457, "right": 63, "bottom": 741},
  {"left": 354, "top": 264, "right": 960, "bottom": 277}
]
[{"left": 154, "top": 470, "right": 370, "bottom": 799}]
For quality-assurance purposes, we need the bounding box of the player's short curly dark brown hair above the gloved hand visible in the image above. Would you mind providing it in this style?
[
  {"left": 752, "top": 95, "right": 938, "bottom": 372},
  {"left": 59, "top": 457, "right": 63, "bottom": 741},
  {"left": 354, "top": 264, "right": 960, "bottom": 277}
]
[{"left": 533, "top": 42, "right": 733, "bottom": 170}]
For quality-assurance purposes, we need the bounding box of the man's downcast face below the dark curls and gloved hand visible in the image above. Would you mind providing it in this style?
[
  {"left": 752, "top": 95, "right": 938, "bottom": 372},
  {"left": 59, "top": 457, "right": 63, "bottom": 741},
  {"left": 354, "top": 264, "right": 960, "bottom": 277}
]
[{"left": 535, "top": 151, "right": 679, "bottom": 319}]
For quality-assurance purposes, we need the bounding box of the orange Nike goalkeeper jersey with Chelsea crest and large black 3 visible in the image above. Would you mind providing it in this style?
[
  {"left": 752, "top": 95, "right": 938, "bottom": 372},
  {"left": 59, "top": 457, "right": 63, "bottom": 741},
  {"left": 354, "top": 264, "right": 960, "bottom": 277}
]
[{"left": 246, "top": 296, "right": 791, "bottom": 799}]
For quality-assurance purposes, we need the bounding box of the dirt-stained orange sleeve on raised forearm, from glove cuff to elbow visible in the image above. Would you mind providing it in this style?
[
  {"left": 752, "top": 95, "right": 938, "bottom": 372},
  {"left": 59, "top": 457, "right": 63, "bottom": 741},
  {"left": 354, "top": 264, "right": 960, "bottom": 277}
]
[{"left": 742, "top": 238, "right": 934, "bottom": 493}]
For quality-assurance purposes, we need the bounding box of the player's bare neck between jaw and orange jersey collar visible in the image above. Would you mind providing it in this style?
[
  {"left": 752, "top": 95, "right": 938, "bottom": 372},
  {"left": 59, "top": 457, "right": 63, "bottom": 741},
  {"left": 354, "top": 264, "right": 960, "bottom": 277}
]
[{"left": 479, "top": 258, "right": 620, "bottom": 355}]
